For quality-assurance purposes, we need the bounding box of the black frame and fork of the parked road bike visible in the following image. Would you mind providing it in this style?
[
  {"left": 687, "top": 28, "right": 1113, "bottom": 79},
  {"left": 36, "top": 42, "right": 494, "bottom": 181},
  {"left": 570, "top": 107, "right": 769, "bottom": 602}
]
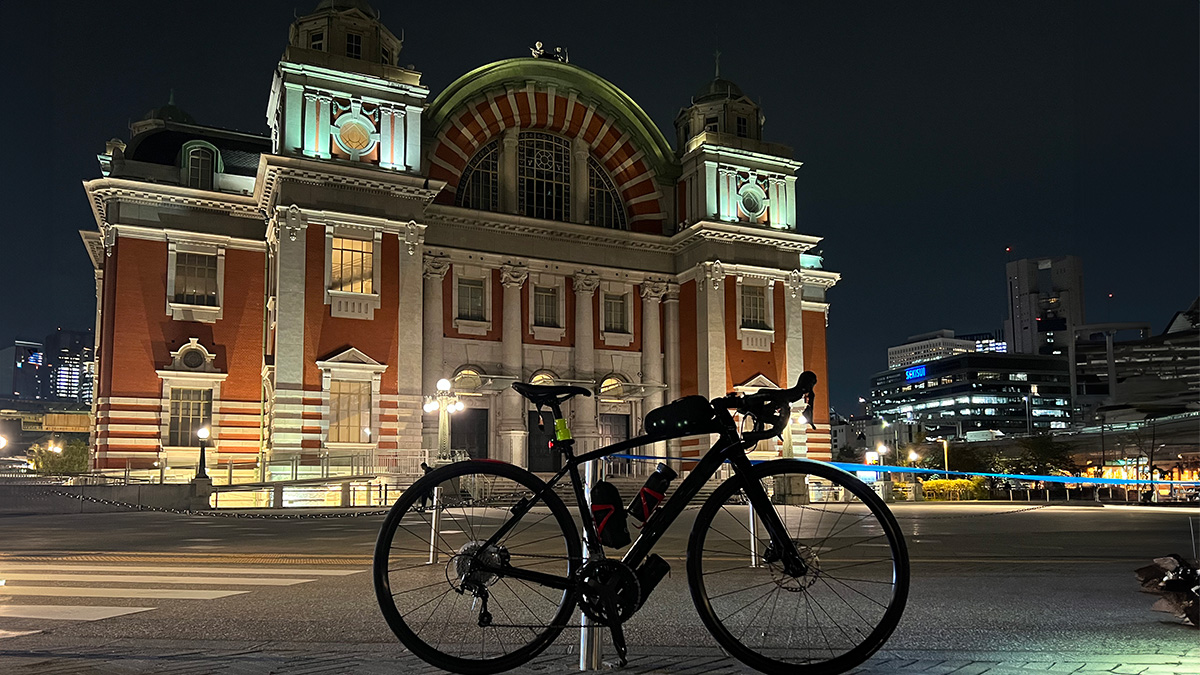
[{"left": 481, "top": 398, "right": 805, "bottom": 589}]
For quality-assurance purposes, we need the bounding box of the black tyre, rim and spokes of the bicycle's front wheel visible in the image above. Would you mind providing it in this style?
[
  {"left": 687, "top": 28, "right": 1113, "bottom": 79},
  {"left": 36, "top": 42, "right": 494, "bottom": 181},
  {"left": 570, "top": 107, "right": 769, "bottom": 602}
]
[{"left": 688, "top": 459, "right": 910, "bottom": 675}]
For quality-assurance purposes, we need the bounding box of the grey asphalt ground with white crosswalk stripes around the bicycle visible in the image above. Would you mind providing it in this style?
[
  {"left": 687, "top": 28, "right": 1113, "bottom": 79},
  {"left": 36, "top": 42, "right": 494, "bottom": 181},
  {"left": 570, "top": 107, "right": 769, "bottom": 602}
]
[{"left": 0, "top": 502, "right": 1200, "bottom": 675}]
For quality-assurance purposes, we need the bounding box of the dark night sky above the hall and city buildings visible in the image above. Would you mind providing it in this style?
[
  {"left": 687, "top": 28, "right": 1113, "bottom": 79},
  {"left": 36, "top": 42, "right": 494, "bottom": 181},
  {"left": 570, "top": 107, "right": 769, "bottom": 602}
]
[{"left": 0, "top": 0, "right": 1200, "bottom": 413}]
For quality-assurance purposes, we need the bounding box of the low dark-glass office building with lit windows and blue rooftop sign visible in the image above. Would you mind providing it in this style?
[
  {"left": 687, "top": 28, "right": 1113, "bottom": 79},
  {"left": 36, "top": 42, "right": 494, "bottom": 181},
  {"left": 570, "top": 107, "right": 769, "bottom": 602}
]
[{"left": 871, "top": 353, "right": 1070, "bottom": 437}]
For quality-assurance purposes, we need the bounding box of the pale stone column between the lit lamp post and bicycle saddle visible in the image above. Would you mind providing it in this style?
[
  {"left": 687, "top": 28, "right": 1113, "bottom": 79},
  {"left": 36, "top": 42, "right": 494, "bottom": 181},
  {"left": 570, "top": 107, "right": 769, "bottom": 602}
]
[{"left": 499, "top": 264, "right": 529, "bottom": 467}]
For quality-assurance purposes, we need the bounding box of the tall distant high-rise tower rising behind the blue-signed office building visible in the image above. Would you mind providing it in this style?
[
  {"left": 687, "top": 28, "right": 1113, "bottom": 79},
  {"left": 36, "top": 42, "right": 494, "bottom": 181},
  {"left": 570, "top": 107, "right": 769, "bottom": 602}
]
[{"left": 1004, "top": 256, "right": 1084, "bottom": 354}]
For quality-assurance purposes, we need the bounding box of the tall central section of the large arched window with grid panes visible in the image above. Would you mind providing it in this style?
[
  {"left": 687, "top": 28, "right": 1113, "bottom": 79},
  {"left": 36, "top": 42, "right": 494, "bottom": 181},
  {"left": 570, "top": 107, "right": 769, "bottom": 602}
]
[{"left": 517, "top": 131, "right": 571, "bottom": 221}]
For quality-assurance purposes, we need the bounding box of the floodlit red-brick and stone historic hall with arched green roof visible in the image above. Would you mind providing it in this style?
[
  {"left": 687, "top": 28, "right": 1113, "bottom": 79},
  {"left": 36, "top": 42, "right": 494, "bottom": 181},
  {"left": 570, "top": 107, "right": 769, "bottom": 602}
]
[{"left": 83, "top": 0, "right": 839, "bottom": 471}]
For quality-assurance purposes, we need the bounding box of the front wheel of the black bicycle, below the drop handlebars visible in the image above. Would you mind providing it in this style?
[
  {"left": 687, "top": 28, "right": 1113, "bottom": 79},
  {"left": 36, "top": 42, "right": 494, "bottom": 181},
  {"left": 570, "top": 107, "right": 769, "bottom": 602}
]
[{"left": 688, "top": 459, "right": 908, "bottom": 675}]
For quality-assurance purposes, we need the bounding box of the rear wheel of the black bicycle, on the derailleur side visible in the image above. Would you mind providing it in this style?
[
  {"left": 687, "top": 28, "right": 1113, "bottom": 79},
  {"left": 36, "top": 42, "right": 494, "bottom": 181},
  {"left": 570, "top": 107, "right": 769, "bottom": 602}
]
[{"left": 373, "top": 460, "right": 582, "bottom": 675}]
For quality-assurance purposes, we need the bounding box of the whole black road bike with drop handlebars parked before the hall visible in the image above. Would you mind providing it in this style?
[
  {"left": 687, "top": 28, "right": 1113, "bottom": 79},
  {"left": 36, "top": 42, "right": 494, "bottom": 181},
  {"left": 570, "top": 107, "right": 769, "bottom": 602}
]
[{"left": 373, "top": 372, "right": 908, "bottom": 675}]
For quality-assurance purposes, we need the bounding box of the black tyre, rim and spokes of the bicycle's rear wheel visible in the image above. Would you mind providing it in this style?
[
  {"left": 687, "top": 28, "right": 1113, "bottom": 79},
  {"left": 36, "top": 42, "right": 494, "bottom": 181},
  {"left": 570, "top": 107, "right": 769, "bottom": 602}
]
[{"left": 372, "top": 460, "right": 582, "bottom": 675}]
